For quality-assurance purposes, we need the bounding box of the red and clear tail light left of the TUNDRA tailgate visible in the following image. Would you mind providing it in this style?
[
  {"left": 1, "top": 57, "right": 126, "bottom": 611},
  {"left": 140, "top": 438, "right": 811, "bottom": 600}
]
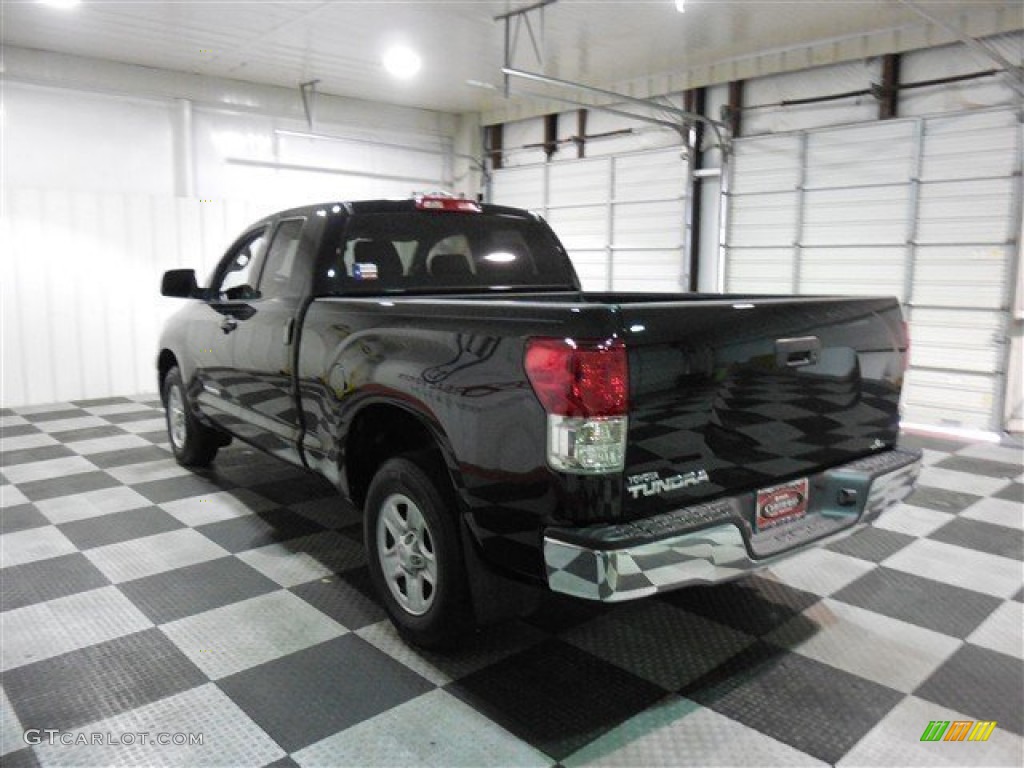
[{"left": 525, "top": 338, "right": 629, "bottom": 474}]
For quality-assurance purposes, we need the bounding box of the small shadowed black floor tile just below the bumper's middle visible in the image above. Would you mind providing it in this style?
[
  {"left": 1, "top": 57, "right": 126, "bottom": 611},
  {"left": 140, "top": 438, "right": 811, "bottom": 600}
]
[{"left": 659, "top": 575, "right": 821, "bottom": 637}]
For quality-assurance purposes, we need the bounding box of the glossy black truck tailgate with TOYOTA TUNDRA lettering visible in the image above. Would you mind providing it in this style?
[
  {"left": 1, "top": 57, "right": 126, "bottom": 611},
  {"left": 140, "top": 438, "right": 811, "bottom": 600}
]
[{"left": 610, "top": 295, "right": 907, "bottom": 519}]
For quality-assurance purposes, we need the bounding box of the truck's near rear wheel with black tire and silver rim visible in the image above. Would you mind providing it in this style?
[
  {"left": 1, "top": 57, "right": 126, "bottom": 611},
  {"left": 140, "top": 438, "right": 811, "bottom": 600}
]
[{"left": 364, "top": 455, "right": 474, "bottom": 649}]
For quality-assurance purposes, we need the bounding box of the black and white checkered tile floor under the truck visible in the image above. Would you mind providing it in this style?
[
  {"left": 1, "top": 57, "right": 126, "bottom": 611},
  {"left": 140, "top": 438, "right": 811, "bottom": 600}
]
[{"left": 0, "top": 396, "right": 1024, "bottom": 768}]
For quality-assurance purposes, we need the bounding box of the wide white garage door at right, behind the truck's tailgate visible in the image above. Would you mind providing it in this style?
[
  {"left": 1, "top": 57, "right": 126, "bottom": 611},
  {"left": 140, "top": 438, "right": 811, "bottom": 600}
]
[{"left": 725, "top": 110, "right": 1021, "bottom": 429}]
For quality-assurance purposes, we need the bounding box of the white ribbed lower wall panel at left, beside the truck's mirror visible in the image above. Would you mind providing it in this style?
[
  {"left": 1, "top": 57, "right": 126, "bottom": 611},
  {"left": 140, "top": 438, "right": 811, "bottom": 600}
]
[{"left": 2, "top": 188, "right": 265, "bottom": 406}]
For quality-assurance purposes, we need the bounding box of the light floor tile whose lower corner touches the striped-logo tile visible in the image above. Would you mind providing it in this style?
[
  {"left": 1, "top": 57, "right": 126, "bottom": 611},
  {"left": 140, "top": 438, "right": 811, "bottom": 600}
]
[{"left": 768, "top": 598, "right": 961, "bottom": 693}]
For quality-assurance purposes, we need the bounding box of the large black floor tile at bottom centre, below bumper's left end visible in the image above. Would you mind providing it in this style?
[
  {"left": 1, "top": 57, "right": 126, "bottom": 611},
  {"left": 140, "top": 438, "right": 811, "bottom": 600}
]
[{"left": 445, "top": 638, "right": 666, "bottom": 760}]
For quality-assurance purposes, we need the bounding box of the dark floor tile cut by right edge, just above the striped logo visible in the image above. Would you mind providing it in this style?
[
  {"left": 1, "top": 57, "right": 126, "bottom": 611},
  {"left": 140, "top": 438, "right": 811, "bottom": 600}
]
[{"left": 914, "top": 643, "right": 1024, "bottom": 736}]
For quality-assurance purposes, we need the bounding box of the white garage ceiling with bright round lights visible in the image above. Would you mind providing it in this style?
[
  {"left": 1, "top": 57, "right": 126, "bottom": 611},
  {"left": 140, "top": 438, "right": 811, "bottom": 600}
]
[{"left": 0, "top": 0, "right": 1024, "bottom": 120}]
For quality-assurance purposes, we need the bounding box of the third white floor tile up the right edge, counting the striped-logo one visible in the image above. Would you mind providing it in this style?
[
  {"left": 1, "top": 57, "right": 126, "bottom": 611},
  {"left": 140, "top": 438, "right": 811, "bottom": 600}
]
[{"left": 882, "top": 539, "right": 1022, "bottom": 598}]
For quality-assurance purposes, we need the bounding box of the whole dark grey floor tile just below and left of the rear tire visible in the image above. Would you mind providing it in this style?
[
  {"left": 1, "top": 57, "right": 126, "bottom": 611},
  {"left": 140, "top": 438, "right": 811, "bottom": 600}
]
[{"left": 217, "top": 634, "right": 434, "bottom": 753}]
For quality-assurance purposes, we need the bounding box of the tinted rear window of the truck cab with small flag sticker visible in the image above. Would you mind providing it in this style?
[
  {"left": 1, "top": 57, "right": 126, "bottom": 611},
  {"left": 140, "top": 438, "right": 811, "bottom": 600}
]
[{"left": 317, "top": 212, "right": 575, "bottom": 295}]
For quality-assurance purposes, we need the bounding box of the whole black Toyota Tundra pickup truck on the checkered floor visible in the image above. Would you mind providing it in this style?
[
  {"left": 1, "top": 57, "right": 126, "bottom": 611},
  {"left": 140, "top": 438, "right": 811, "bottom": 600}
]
[{"left": 157, "top": 197, "right": 920, "bottom": 646}]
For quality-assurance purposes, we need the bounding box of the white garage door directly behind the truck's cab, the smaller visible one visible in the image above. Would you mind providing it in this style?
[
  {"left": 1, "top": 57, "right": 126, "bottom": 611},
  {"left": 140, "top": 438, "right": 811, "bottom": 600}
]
[{"left": 492, "top": 147, "right": 689, "bottom": 292}]
